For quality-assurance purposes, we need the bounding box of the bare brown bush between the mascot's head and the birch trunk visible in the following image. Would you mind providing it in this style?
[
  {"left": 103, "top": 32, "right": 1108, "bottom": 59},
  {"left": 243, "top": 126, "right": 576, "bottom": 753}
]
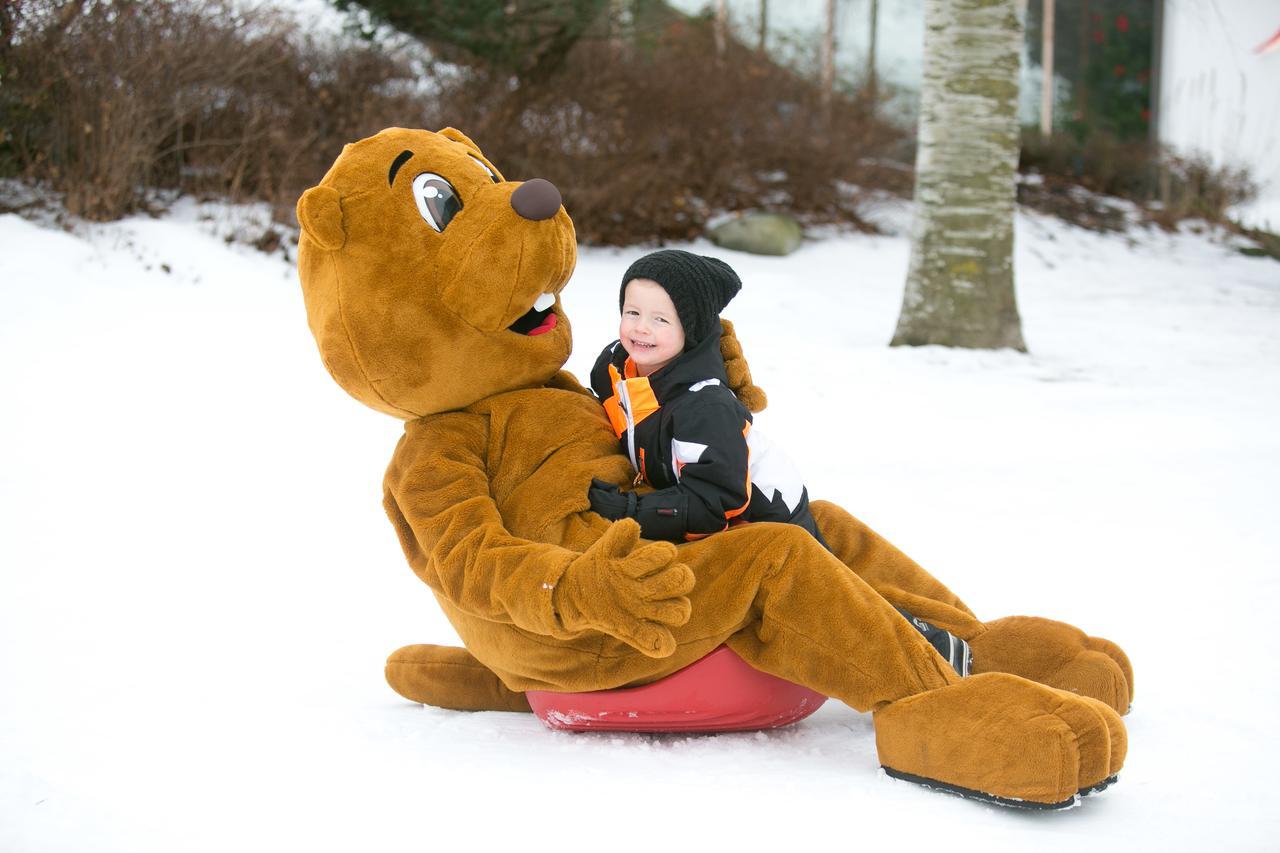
[{"left": 422, "top": 19, "right": 910, "bottom": 245}]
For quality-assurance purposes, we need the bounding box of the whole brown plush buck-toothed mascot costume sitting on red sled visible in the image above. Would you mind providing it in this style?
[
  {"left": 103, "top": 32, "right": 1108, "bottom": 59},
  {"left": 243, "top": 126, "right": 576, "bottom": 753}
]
[{"left": 297, "top": 128, "right": 1133, "bottom": 808}]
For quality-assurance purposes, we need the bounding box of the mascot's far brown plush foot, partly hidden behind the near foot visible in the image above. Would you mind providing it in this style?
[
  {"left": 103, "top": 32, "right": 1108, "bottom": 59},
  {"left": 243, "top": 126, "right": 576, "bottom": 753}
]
[{"left": 969, "top": 616, "right": 1133, "bottom": 713}]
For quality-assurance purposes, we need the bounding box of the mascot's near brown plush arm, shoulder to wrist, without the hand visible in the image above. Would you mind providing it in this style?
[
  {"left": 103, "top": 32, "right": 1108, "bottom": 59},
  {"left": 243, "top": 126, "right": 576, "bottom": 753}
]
[{"left": 383, "top": 412, "right": 580, "bottom": 638}]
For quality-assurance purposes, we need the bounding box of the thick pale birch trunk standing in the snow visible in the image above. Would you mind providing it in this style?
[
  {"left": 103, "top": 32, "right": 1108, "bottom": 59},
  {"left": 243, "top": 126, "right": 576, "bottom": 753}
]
[{"left": 892, "top": 0, "right": 1027, "bottom": 352}]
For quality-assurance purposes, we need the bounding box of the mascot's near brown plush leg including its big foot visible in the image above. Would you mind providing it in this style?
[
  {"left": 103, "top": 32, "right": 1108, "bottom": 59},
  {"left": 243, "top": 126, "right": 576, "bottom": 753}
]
[{"left": 701, "top": 524, "right": 1124, "bottom": 807}]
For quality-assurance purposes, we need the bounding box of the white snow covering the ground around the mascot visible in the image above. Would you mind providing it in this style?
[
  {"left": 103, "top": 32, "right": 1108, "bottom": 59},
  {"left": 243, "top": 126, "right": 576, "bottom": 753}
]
[{"left": 0, "top": 192, "right": 1280, "bottom": 853}]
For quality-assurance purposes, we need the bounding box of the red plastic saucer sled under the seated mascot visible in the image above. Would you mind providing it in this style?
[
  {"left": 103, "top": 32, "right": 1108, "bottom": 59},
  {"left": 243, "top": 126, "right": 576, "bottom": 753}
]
[{"left": 525, "top": 646, "right": 827, "bottom": 731}]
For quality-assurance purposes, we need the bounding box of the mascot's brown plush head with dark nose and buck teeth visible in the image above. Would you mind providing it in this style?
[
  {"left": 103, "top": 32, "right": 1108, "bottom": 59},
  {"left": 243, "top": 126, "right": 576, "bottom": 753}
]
[{"left": 298, "top": 128, "right": 577, "bottom": 419}]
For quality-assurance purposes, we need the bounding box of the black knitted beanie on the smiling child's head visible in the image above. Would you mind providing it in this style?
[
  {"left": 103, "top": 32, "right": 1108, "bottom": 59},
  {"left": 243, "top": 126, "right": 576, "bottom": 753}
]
[{"left": 618, "top": 248, "right": 742, "bottom": 350}]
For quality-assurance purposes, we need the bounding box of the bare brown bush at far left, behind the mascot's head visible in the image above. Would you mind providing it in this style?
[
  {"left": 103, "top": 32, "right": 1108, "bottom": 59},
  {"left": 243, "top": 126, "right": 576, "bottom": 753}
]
[{"left": 0, "top": 0, "right": 431, "bottom": 219}]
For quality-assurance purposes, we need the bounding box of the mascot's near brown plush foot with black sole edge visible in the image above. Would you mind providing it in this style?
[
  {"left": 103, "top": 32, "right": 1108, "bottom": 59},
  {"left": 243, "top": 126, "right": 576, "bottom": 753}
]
[{"left": 874, "top": 674, "right": 1128, "bottom": 808}]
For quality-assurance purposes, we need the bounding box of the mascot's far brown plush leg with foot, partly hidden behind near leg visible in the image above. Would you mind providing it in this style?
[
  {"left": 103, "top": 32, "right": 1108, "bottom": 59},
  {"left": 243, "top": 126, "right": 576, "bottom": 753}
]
[{"left": 810, "top": 501, "right": 1133, "bottom": 713}]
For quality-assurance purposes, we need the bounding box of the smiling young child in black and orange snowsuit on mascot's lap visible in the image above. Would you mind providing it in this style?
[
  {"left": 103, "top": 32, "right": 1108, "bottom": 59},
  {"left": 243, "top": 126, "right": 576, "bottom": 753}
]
[{"left": 588, "top": 250, "right": 972, "bottom": 675}]
